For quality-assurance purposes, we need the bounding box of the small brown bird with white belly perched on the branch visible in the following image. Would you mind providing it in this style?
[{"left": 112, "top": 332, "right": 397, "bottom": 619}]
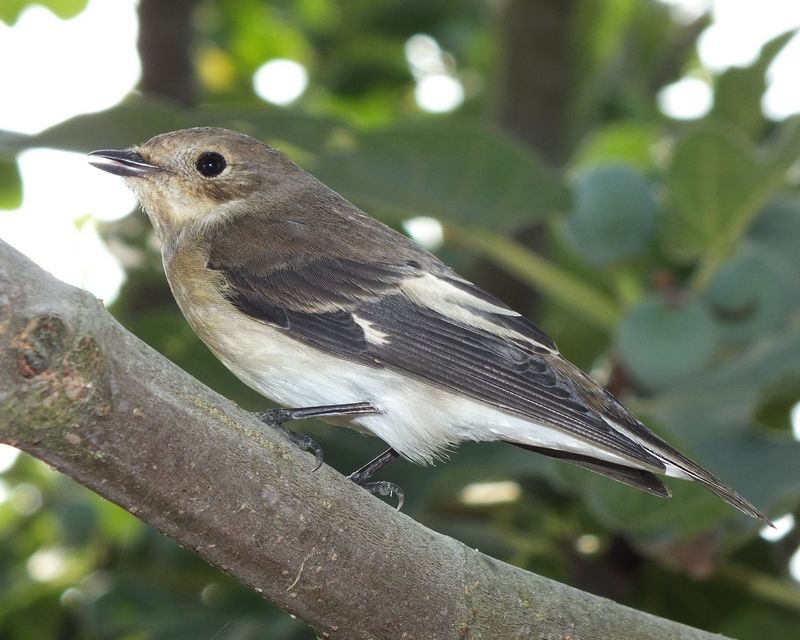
[{"left": 88, "top": 127, "right": 770, "bottom": 523}]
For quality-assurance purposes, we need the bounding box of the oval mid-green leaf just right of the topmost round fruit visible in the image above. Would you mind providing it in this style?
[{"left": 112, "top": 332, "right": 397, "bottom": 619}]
[{"left": 664, "top": 127, "right": 763, "bottom": 260}]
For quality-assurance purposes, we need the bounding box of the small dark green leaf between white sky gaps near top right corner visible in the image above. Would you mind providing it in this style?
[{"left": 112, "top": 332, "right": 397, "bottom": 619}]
[{"left": 711, "top": 31, "right": 795, "bottom": 135}]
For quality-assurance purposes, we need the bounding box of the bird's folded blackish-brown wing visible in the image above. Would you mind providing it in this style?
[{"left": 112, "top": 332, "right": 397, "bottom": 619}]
[{"left": 209, "top": 251, "right": 664, "bottom": 471}]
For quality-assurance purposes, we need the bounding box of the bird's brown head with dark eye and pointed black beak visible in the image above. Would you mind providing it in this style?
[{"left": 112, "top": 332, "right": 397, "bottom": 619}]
[{"left": 89, "top": 127, "right": 298, "bottom": 242}]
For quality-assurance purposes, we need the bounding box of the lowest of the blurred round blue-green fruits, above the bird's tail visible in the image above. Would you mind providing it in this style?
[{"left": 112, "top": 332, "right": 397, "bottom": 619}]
[{"left": 616, "top": 296, "right": 717, "bottom": 389}]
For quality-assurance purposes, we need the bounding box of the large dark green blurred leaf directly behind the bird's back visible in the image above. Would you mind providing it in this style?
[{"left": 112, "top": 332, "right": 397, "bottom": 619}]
[{"left": 313, "top": 122, "right": 568, "bottom": 230}]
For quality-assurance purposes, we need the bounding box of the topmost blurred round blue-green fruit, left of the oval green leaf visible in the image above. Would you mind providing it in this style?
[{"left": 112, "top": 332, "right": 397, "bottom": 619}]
[{"left": 566, "top": 165, "right": 658, "bottom": 265}]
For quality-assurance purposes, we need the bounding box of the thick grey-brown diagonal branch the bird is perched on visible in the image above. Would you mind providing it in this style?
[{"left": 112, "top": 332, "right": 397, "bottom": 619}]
[{"left": 0, "top": 242, "right": 719, "bottom": 640}]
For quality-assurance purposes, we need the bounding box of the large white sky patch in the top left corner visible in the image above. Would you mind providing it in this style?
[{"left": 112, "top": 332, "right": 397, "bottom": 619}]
[{"left": 0, "top": 0, "right": 141, "bottom": 133}]
